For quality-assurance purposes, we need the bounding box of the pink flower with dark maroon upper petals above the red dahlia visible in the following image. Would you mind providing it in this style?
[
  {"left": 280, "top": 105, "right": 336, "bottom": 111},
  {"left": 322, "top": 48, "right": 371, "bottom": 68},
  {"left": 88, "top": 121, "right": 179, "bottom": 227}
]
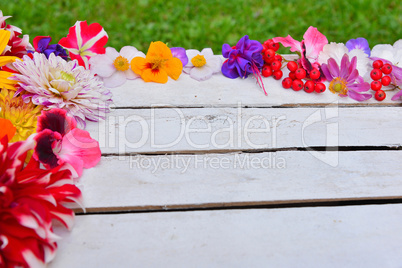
[{"left": 33, "top": 109, "right": 101, "bottom": 177}]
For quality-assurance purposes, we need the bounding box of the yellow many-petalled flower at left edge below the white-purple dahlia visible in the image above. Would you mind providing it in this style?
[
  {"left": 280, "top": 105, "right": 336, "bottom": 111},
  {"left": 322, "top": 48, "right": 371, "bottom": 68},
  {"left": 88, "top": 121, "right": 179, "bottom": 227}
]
[{"left": 0, "top": 89, "right": 42, "bottom": 142}]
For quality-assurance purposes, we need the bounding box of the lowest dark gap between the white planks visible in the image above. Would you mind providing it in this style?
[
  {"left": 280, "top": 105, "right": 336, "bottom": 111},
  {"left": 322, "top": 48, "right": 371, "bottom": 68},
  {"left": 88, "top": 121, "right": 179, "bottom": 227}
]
[{"left": 73, "top": 196, "right": 402, "bottom": 215}]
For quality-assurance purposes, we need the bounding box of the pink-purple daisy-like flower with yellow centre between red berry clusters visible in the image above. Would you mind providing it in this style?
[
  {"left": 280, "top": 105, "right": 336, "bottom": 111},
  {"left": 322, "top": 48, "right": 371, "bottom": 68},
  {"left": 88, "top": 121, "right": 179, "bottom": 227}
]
[{"left": 321, "top": 54, "right": 372, "bottom": 101}]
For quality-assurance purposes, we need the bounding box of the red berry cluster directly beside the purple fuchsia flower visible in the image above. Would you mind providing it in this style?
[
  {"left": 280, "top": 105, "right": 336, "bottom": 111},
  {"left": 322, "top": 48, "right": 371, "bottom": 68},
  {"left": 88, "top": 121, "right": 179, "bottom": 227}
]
[{"left": 262, "top": 39, "right": 283, "bottom": 80}]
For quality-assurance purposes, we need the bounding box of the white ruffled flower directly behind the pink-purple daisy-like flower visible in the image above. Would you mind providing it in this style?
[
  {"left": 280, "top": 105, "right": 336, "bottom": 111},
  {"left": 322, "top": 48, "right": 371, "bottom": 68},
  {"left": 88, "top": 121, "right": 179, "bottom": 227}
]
[{"left": 318, "top": 42, "right": 370, "bottom": 77}]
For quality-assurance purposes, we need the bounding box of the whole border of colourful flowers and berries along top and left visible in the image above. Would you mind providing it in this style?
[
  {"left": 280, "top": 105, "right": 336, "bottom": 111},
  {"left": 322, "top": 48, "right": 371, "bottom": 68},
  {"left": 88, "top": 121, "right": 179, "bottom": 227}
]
[{"left": 0, "top": 11, "right": 402, "bottom": 267}]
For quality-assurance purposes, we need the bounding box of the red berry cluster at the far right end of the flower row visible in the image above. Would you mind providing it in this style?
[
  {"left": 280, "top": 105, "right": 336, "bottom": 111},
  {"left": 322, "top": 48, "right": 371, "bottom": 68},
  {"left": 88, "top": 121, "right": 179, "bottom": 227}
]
[{"left": 370, "top": 60, "right": 392, "bottom": 101}]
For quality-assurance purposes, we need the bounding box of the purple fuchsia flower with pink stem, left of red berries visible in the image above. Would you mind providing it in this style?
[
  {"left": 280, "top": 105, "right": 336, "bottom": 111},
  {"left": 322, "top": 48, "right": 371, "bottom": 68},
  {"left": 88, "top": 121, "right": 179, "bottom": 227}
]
[{"left": 221, "top": 35, "right": 268, "bottom": 95}]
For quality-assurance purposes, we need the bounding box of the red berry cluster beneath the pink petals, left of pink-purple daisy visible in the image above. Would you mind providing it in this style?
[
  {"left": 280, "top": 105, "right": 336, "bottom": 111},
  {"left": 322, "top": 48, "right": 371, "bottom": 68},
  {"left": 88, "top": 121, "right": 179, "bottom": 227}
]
[{"left": 282, "top": 61, "right": 326, "bottom": 93}]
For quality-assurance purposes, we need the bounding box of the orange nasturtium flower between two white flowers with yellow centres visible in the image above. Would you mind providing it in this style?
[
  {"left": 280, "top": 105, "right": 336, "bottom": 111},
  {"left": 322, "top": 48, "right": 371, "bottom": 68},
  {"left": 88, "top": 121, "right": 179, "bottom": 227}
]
[{"left": 131, "top": 41, "right": 183, "bottom": 83}]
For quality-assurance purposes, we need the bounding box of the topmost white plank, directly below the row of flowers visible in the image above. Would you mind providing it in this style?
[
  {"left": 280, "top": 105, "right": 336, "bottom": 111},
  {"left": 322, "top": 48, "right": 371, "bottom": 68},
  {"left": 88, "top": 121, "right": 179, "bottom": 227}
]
[{"left": 111, "top": 54, "right": 400, "bottom": 107}]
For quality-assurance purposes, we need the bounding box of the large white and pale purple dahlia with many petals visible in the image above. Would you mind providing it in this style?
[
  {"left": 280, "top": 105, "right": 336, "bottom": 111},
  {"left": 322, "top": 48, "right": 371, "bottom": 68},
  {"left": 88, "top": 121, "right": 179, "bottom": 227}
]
[{"left": 12, "top": 53, "right": 112, "bottom": 126}]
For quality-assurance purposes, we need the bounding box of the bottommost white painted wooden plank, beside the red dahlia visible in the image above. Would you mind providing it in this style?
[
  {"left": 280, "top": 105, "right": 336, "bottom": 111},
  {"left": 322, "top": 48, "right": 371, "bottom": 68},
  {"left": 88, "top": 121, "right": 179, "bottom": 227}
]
[{"left": 49, "top": 204, "right": 402, "bottom": 268}]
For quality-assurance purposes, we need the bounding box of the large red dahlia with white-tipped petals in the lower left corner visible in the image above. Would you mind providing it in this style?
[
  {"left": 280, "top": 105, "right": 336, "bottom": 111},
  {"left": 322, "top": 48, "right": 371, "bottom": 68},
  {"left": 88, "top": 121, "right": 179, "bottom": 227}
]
[{"left": 0, "top": 137, "right": 82, "bottom": 268}]
